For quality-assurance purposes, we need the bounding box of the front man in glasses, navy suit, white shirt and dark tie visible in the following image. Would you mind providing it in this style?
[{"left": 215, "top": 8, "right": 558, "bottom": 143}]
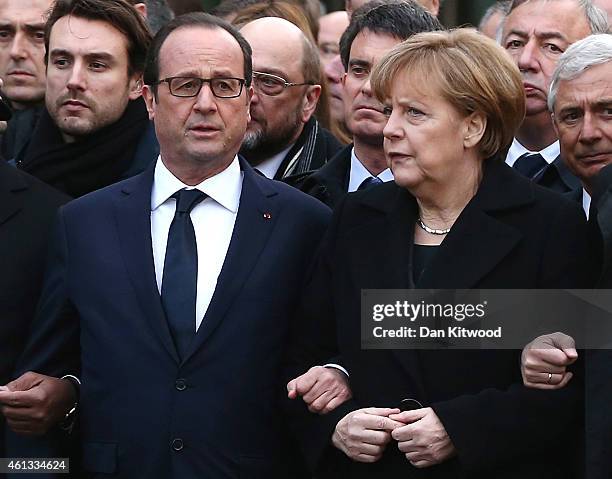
[{"left": 0, "top": 13, "right": 329, "bottom": 479}]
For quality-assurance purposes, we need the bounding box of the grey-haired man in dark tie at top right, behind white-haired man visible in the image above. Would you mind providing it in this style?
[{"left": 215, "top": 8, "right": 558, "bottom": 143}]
[{"left": 502, "top": 0, "right": 608, "bottom": 193}]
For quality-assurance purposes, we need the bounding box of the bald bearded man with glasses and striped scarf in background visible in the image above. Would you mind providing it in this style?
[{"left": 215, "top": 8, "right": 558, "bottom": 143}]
[{"left": 240, "top": 18, "right": 341, "bottom": 184}]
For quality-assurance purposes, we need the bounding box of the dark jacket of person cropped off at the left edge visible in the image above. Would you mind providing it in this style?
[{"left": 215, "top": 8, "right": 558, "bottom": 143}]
[{"left": 0, "top": 161, "right": 69, "bottom": 449}]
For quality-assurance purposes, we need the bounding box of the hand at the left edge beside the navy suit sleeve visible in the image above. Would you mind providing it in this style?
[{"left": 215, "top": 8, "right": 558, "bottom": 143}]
[{"left": 0, "top": 372, "right": 76, "bottom": 436}]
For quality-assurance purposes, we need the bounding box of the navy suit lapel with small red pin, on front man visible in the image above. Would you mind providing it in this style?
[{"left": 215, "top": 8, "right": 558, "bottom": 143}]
[{"left": 185, "top": 160, "right": 279, "bottom": 360}]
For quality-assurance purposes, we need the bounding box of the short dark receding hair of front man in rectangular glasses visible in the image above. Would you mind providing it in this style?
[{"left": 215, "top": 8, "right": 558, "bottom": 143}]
[{"left": 144, "top": 12, "right": 253, "bottom": 94}]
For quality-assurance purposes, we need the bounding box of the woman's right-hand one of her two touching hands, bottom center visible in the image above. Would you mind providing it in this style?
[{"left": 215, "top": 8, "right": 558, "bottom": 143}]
[{"left": 389, "top": 407, "right": 456, "bottom": 468}]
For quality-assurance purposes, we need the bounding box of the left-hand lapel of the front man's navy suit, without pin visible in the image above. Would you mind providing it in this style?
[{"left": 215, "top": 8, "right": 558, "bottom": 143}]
[{"left": 115, "top": 163, "right": 179, "bottom": 362}]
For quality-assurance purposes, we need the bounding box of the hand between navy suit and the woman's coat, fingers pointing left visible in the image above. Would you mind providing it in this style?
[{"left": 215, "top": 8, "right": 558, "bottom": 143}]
[{"left": 287, "top": 366, "right": 353, "bottom": 414}]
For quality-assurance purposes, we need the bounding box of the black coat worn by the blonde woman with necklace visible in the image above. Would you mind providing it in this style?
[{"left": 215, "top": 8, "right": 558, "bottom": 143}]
[{"left": 285, "top": 161, "right": 592, "bottom": 479}]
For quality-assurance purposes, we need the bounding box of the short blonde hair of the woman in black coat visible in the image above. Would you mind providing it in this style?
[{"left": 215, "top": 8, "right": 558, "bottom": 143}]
[{"left": 371, "top": 28, "right": 525, "bottom": 158}]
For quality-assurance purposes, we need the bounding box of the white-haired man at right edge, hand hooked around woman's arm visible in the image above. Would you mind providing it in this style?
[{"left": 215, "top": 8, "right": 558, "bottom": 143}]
[{"left": 522, "top": 34, "right": 612, "bottom": 479}]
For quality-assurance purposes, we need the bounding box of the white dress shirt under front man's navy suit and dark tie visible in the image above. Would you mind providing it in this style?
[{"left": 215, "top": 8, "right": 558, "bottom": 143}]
[{"left": 151, "top": 157, "right": 243, "bottom": 331}]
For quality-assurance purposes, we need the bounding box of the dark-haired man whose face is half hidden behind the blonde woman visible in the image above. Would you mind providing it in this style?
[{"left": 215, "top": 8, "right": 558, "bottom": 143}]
[{"left": 299, "top": 1, "right": 442, "bottom": 207}]
